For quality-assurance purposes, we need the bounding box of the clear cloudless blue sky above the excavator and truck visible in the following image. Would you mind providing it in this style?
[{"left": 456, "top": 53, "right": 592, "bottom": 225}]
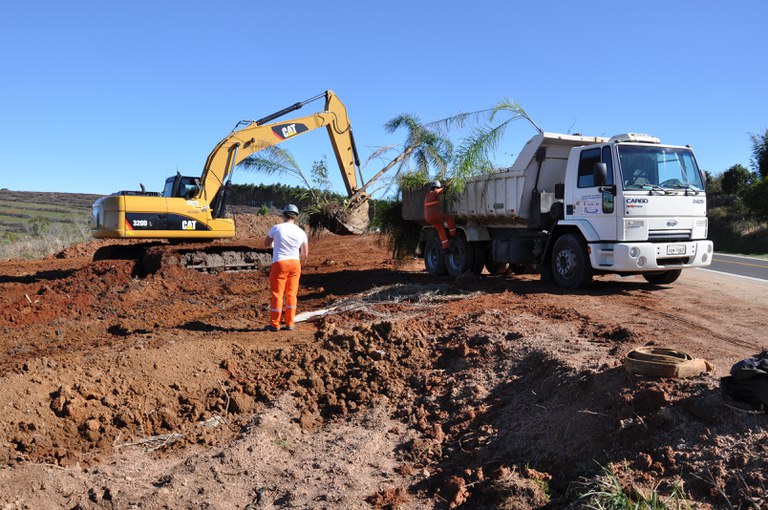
[{"left": 0, "top": 0, "right": 768, "bottom": 194}]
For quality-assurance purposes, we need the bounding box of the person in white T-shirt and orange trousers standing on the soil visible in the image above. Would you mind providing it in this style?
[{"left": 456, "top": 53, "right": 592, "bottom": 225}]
[{"left": 264, "top": 204, "right": 309, "bottom": 331}]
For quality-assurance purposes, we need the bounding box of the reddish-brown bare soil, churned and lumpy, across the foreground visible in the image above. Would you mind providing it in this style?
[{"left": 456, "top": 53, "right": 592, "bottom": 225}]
[{"left": 0, "top": 214, "right": 768, "bottom": 509}]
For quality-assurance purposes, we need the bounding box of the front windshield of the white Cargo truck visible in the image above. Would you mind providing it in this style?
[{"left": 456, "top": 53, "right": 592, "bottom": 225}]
[{"left": 618, "top": 145, "right": 704, "bottom": 191}]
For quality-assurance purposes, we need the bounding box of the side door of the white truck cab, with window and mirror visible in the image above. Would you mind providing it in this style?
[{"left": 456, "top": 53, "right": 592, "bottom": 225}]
[{"left": 573, "top": 145, "right": 617, "bottom": 240}]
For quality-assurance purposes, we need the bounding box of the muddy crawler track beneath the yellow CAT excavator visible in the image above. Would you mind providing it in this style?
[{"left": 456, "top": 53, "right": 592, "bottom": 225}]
[{"left": 93, "top": 242, "right": 272, "bottom": 275}]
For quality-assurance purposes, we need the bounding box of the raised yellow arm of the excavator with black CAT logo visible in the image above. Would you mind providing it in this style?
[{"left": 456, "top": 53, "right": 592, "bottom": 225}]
[{"left": 195, "top": 90, "right": 367, "bottom": 209}]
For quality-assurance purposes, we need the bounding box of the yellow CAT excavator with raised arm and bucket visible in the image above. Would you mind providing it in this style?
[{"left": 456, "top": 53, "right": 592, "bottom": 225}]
[{"left": 91, "top": 90, "right": 369, "bottom": 269}]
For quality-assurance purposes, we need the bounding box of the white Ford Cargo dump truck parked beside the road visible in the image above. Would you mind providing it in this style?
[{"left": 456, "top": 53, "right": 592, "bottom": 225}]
[{"left": 403, "top": 132, "right": 713, "bottom": 289}]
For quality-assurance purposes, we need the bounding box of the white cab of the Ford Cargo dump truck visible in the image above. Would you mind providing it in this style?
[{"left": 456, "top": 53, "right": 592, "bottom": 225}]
[{"left": 551, "top": 133, "right": 713, "bottom": 287}]
